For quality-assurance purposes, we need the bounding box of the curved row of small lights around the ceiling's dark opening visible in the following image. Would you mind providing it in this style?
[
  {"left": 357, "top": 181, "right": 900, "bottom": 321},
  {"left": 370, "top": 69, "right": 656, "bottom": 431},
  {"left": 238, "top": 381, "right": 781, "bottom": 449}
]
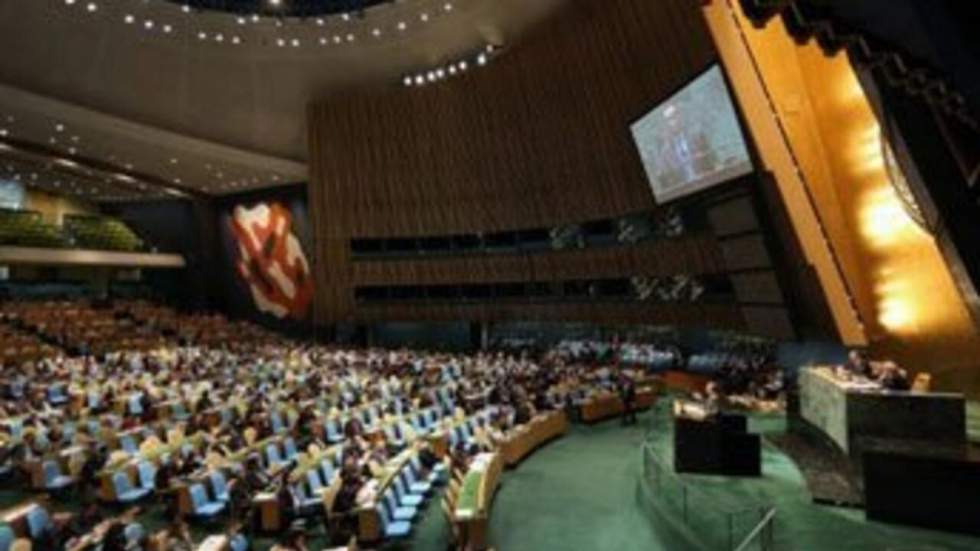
[{"left": 64, "top": 0, "right": 455, "bottom": 48}]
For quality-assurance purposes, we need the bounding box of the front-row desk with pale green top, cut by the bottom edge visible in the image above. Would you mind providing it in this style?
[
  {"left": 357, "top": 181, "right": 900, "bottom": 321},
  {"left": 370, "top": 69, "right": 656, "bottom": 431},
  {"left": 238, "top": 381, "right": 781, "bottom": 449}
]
[{"left": 453, "top": 453, "right": 504, "bottom": 551}]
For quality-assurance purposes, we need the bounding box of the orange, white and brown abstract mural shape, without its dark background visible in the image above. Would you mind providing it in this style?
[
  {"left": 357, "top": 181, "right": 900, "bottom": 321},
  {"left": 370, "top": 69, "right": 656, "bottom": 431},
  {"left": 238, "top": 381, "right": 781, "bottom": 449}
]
[{"left": 230, "top": 202, "right": 313, "bottom": 319}]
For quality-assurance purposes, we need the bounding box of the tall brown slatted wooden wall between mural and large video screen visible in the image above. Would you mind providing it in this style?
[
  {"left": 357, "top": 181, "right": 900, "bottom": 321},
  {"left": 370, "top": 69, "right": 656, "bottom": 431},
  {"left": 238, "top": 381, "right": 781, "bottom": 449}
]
[{"left": 308, "top": 0, "right": 720, "bottom": 322}]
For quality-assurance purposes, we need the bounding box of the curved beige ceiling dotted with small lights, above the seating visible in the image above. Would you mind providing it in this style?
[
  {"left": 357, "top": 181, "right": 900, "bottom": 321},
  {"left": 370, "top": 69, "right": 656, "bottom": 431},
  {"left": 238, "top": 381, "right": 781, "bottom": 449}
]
[{"left": 0, "top": 0, "right": 569, "bottom": 201}]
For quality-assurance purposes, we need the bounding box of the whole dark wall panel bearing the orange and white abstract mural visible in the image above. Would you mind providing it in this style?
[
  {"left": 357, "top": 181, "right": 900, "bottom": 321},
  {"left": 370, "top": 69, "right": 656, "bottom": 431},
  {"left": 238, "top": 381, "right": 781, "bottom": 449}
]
[{"left": 217, "top": 185, "right": 314, "bottom": 332}]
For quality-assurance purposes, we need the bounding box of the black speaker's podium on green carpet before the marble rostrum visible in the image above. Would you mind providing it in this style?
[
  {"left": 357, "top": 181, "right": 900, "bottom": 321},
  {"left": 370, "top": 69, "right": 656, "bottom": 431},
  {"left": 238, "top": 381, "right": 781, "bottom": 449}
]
[{"left": 674, "top": 406, "right": 762, "bottom": 476}]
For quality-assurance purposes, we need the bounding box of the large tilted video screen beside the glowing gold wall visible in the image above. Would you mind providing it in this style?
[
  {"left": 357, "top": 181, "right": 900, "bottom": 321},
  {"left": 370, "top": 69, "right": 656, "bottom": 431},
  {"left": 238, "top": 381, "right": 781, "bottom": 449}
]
[{"left": 630, "top": 65, "right": 752, "bottom": 203}]
